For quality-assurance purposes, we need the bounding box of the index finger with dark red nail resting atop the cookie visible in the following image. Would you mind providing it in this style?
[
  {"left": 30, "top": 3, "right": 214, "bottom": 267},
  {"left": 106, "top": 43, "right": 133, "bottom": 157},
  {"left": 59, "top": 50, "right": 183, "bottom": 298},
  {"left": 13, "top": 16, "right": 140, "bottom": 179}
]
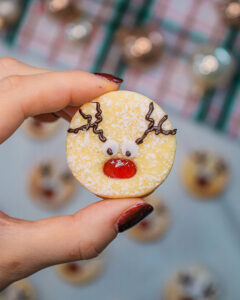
[{"left": 0, "top": 71, "right": 122, "bottom": 142}]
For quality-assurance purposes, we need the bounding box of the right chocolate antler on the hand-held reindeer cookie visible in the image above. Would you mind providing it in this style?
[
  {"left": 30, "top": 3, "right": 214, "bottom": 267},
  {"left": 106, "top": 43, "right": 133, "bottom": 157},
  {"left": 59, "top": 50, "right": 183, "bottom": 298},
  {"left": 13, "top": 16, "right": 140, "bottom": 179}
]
[{"left": 135, "top": 102, "right": 177, "bottom": 145}]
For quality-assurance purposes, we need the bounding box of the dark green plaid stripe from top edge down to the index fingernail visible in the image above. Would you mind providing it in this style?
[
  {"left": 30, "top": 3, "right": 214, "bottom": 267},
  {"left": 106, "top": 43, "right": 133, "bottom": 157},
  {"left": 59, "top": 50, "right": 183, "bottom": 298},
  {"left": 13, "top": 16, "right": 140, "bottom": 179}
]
[{"left": 91, "top": 0, "right": 130, "bottom": 72}]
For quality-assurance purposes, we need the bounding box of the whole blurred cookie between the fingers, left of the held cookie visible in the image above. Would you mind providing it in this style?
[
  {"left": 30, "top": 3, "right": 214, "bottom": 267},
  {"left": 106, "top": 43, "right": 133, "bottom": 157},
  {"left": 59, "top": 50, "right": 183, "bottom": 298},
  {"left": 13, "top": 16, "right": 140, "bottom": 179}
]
[{"left": 28, "top": 161, "right": 76, "bottom": 209}]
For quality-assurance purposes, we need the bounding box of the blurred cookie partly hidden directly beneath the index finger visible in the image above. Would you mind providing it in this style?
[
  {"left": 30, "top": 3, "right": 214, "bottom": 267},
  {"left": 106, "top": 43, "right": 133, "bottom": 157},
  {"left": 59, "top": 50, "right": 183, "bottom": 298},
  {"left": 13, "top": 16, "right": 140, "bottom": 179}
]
[{"left": 23, "top": 118, "right": 61, "bottom": 139}]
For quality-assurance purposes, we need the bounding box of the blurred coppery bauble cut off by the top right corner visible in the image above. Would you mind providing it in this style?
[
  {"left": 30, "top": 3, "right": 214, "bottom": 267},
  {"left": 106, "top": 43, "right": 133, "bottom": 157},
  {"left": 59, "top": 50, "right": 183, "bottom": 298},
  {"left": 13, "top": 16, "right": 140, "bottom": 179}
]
[{"left": 218, "top": 0, "right": 240, "bottom": 28}]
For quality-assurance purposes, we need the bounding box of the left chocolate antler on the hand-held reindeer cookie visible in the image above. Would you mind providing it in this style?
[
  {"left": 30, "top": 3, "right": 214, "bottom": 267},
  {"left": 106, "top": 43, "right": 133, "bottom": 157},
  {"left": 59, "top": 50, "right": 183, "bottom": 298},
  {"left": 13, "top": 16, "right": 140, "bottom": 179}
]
[{"left": 68, "top": 102, "right": 107, "bottom": 142}]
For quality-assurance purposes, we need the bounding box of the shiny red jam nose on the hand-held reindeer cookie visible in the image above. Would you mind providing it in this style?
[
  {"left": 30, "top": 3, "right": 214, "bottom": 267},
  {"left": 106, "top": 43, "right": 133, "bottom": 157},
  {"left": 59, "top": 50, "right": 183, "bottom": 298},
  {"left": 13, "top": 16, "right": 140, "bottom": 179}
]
[{"left": 103, "top": 158, "right": 137, "bottom": 179}]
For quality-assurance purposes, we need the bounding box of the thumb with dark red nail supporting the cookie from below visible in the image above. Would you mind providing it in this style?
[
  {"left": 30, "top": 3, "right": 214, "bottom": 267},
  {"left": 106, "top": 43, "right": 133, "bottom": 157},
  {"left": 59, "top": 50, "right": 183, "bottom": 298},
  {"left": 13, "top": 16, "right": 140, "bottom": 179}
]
[{"left": 0, "top": 199, "right": 153, "bottom": 288}]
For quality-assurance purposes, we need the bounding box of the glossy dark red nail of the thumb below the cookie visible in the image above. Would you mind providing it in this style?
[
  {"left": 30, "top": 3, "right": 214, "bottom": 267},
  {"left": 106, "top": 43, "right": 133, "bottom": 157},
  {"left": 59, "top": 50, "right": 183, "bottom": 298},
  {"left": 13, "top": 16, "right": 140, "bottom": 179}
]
[{"left": 115, "top": 203, "right": 153, "bottom": 233}]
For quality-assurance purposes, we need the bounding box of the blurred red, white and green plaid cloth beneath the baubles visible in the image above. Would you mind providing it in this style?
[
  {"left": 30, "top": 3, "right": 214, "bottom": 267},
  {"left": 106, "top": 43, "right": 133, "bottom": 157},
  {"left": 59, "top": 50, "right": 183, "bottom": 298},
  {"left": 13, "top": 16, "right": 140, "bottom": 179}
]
[{"left": 3, "top": 0, "right": 240, "bottom": 139}]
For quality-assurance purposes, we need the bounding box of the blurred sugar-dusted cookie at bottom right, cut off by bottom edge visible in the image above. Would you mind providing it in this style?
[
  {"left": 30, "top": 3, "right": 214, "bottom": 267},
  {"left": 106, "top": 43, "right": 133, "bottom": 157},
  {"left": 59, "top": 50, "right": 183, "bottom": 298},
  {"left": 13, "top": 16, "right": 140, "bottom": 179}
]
[{"left": 164, "top": 266, "right": 218, "bottom": 300}]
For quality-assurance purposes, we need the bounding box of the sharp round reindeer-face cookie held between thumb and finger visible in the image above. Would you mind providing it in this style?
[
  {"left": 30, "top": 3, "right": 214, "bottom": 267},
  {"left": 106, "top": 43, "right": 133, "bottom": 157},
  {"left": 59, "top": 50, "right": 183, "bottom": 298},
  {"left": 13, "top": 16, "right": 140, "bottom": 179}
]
[{"left": 67, "top": 91, "right": 176, "bottom": 198}]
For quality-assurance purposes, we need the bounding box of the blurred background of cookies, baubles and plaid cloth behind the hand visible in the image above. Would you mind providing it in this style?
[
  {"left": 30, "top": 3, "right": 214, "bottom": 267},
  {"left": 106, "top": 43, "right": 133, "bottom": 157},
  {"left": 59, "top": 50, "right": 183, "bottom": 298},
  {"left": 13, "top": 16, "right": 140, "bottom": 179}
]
[{"left": 0, "top": 0, "right": 240, "bottom": 300}]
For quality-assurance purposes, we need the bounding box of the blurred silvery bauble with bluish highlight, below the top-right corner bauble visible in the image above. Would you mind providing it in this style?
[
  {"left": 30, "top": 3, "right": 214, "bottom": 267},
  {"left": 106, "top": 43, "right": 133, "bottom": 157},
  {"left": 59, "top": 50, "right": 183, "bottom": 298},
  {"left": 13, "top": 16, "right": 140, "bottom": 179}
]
[{"left": 190, "top": 46, "right": 235, "bottom": 91}]
